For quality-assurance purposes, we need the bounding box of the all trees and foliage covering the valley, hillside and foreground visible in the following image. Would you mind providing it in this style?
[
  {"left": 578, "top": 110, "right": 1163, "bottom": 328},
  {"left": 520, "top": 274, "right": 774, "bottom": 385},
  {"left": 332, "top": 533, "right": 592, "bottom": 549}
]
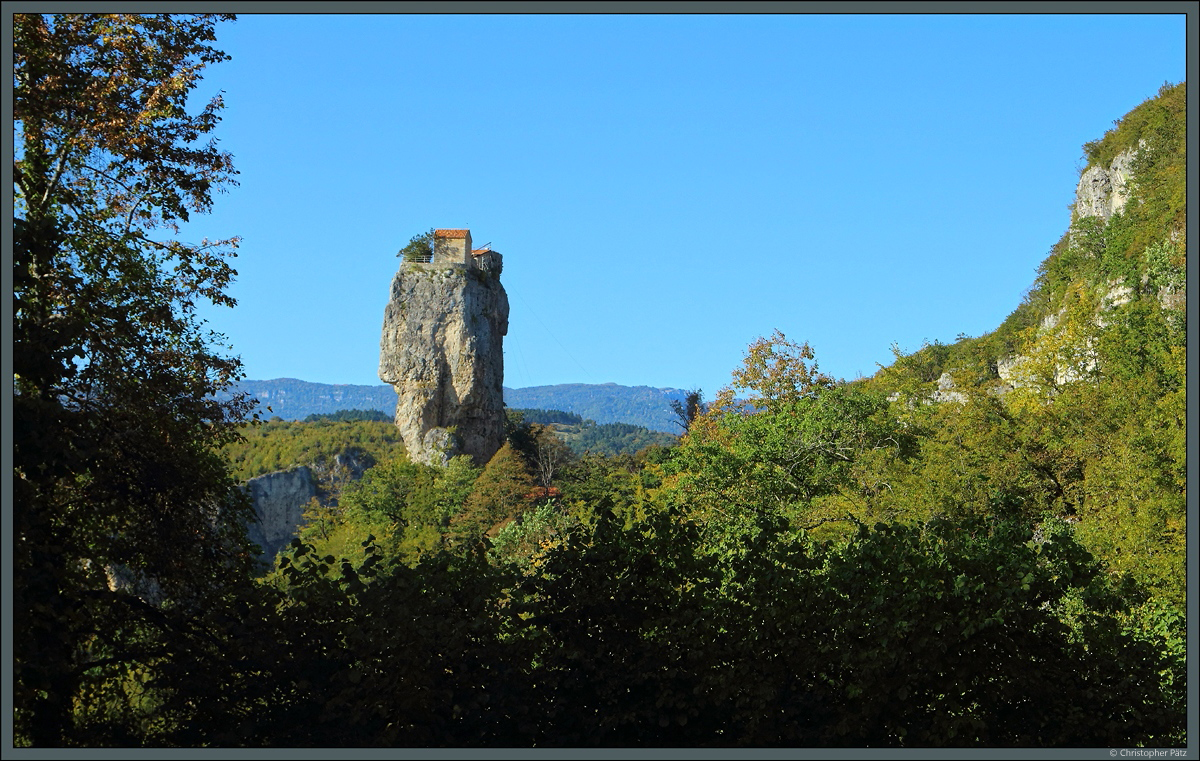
[{"left": 13, "top": 14, "right": 1188, "bottom": 747}]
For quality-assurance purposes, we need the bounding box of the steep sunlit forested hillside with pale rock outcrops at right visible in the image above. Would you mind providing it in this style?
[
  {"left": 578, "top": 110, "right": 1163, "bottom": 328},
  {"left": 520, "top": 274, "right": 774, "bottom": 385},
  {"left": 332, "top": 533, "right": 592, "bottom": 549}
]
[{"left": 864, "top": 83, "right": 1187, "bottom": 604}]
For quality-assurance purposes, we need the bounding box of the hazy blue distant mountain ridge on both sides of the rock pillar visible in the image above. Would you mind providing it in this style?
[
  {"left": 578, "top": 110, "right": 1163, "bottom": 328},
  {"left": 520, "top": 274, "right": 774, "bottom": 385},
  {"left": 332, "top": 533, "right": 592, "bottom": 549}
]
[{"left": 226, "top": 378, "right": 686, "bottom": 433}]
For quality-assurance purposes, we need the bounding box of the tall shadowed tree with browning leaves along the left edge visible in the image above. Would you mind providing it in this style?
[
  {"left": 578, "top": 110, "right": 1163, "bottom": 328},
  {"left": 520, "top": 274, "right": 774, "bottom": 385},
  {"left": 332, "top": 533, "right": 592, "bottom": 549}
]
[{"left": 13, "top": 13, "right": 250, "bottom": 745}]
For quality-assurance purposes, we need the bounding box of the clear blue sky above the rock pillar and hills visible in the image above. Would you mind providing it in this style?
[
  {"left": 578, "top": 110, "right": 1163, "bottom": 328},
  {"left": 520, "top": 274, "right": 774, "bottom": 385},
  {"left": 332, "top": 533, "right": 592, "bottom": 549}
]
[{"left": 185, "top": 14, "right": 1186, "bottom": 397}]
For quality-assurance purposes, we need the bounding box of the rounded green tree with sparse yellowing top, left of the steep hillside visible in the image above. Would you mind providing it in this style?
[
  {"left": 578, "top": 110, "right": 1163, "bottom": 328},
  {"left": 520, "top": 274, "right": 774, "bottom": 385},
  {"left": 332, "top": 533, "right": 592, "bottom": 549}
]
[{"left": 670, "top": 331, "right": 911, "bottom": 537}]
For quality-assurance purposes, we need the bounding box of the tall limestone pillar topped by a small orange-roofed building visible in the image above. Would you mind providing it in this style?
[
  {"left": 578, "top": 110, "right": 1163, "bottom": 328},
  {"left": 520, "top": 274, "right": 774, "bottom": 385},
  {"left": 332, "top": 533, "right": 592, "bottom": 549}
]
[{"left": 379, "top": 230, "right": 509, "bottom": 466}]
